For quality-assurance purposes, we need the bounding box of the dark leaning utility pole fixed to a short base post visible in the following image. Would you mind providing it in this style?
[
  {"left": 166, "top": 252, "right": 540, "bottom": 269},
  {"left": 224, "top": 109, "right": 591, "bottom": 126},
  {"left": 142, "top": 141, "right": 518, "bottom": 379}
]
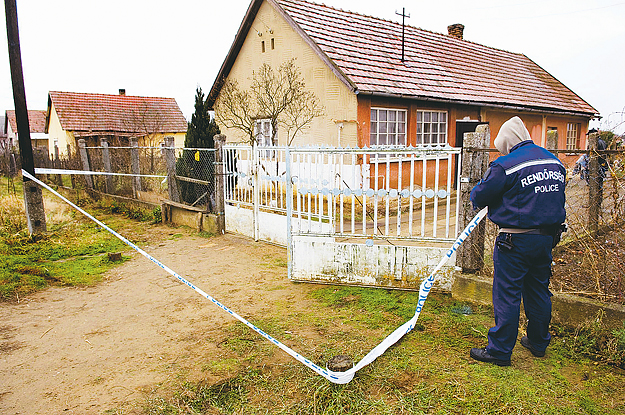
[{"left": 4, "top": 0, "right": 46, "bottom": 235}]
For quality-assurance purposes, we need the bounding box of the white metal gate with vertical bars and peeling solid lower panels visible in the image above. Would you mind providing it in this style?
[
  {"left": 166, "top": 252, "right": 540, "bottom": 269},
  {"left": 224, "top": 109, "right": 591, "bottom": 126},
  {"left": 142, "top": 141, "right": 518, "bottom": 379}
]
[{"left": 223, "top": 145, "right": 461, "bottom": 288}]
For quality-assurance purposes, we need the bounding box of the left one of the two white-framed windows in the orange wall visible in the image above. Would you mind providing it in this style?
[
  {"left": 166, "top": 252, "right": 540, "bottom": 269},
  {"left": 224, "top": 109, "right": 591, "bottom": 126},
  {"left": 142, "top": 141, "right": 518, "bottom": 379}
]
[{"left": 369, "top": 108, "right": 406, "bottom": 147}]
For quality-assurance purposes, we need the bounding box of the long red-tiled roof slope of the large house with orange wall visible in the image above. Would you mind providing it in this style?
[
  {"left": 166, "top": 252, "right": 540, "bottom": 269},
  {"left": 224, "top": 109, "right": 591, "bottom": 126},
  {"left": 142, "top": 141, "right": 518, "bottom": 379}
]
[{"left": 270, "top": 0, "right": 597, "bottom": 115}]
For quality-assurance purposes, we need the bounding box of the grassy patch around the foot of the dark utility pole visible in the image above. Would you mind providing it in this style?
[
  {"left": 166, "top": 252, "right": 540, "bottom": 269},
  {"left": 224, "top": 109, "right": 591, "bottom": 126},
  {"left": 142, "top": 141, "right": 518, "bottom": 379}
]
[{"left": 0, "top": 174, "right": 137, "bottom": 300}]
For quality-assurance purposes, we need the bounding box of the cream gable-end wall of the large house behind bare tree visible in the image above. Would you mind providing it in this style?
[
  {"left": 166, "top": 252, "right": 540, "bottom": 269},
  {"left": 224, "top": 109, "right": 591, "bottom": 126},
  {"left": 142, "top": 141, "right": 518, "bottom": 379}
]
[{"left": 219, "top": 2, "right": 357, "bottom": 147}]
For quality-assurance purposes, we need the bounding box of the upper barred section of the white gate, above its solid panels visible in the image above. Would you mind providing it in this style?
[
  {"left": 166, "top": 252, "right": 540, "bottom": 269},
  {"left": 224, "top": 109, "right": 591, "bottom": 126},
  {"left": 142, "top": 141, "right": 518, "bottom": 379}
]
[{"left": 223, "top": 145, "right": 460, "bottom": 245}]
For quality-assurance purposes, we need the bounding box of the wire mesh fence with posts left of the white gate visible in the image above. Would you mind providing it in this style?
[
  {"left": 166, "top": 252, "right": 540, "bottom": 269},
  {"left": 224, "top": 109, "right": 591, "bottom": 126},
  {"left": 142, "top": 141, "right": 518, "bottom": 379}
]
[{"left": 0, "top": 146, "right": 215, "bottom": 211}]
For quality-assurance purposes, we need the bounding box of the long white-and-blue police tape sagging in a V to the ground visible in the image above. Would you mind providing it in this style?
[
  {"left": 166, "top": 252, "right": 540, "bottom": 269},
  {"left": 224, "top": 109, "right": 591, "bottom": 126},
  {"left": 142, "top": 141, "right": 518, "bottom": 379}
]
[{"left": 22, "top": 170, "right": 487, "bottom": 384}]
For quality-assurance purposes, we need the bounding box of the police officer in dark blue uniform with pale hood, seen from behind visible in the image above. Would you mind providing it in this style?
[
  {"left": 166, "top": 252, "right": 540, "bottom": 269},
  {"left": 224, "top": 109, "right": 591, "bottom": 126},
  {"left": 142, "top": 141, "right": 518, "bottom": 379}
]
[{"left": 470, "top": 117, "right": 566, "bottom": 366}]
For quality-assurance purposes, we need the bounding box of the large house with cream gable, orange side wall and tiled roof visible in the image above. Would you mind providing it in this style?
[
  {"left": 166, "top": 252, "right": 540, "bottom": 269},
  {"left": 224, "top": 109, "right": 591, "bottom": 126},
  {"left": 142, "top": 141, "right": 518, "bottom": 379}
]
[{"left": 208, "top": 0, "right": 599, "bottom": 161}]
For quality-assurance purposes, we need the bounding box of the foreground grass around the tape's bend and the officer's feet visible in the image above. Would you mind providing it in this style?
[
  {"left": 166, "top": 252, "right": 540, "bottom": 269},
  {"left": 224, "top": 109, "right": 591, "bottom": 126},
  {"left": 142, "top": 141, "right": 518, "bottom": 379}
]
[{"left": 144, "top": 286, "right": 625, "bottom": 415}]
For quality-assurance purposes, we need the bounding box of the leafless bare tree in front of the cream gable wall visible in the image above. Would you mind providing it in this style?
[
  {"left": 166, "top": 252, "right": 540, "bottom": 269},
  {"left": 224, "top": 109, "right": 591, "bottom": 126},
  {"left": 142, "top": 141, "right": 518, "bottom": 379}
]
[{"left": 215, "top": 59, "right": 324, "bottom": 145}]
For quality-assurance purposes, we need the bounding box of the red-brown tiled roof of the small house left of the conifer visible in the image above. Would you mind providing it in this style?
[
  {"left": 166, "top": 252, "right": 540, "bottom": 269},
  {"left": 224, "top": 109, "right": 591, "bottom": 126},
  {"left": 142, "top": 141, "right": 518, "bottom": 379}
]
[{"left": 48, "top": 91, "right": 187, "bottom": 136}]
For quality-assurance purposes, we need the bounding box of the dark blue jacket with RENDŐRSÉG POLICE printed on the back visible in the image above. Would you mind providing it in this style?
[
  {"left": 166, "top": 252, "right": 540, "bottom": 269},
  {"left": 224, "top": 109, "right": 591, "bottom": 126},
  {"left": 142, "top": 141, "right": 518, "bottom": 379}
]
[{"left": 471, "top": 140, "right": 566, "bottom": 229}]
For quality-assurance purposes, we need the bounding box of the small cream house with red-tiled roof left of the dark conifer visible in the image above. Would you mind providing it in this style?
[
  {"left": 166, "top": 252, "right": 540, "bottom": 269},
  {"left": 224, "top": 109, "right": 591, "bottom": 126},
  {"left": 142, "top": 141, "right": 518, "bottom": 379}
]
[{"left": 45, "top": 89, "right": 187, "bottom": 154}]
